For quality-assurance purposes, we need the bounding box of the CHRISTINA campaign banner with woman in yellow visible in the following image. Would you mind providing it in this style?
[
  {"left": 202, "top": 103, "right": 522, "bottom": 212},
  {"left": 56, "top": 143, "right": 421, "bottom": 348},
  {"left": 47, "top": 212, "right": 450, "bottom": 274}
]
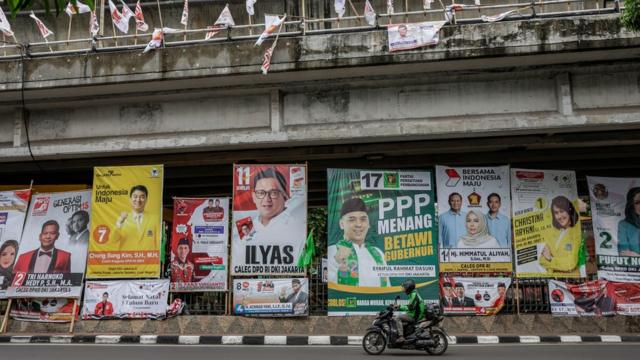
[{"left": 511, "top": 169, "right": 586, "bottom": 278}]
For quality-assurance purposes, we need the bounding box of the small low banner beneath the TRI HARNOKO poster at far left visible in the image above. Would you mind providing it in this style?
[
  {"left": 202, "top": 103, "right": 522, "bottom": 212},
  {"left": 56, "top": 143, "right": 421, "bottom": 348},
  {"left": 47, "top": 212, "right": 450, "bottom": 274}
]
[{"left": 10, "top": 298, "right": 80, "bottom": 323}]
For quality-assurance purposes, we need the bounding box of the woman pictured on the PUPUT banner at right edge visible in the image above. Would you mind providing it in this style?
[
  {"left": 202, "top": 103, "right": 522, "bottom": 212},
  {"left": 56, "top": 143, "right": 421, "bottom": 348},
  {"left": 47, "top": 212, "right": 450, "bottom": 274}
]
[{"left": 618, "top": 187, "right": 640, "bottom": 256}]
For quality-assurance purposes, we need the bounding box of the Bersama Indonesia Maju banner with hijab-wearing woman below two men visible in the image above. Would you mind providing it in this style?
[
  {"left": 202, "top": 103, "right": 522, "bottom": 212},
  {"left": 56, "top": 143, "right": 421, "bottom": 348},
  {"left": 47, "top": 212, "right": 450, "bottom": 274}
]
[{"left": 436, "top": 166, "right": 513, "bottom": 272}]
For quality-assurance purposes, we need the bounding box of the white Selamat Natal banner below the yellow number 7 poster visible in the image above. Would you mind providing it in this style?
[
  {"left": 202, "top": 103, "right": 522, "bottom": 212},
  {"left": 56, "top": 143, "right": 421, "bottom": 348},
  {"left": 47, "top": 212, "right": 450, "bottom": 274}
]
[{"left": 82, "top": 279, "right": 169, "bottom": 320}]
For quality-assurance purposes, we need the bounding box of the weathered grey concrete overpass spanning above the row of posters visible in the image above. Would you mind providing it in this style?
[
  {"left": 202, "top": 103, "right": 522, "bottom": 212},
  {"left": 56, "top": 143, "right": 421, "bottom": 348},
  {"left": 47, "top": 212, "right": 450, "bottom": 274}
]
[{"left": 0, "top": 1, "right": 640, "bottom": 204}]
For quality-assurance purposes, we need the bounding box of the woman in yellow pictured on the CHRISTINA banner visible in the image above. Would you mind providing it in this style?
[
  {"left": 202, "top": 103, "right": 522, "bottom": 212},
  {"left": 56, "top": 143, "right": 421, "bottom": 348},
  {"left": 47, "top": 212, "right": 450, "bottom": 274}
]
[{"left": 539, "top": 196, "right": 582, "bottom": 273}]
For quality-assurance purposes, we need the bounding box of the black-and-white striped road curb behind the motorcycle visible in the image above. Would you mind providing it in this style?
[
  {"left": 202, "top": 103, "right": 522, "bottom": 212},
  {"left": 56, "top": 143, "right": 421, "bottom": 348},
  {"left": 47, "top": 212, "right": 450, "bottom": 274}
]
[{"left": 0, "top": 335, "right": 640, "bottom": 346}]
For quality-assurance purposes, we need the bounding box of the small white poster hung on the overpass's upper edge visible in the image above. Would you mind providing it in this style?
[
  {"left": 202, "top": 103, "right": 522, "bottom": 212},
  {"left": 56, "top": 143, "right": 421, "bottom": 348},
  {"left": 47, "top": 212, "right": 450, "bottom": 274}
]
[{"left": 387, "top": 21, "right": 445, "bottom": 52}]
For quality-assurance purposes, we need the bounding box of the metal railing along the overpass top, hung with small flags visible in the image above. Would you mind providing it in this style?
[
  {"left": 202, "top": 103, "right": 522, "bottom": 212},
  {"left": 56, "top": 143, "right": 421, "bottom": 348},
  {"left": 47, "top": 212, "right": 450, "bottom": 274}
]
[{"left": 0, "top": 0, "right": 623, "bottom": 59}]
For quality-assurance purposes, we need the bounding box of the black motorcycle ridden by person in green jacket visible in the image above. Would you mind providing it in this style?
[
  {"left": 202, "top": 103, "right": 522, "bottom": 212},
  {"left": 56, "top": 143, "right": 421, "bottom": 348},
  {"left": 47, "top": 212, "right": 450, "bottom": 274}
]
[{"left": 362, "top": 298, "right": 449, "bottom": 355}]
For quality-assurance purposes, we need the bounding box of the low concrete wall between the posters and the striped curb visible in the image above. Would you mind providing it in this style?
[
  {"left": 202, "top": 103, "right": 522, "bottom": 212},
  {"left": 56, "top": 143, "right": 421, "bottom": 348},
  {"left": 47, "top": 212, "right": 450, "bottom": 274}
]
[{"left": 8, "top": 314, "right": 640, "bottom": 335}]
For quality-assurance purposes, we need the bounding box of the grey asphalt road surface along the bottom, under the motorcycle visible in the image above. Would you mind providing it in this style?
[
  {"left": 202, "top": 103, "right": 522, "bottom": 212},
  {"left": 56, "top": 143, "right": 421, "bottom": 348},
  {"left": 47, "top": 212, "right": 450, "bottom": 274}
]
[{"left": 0, "top": 344, "right": 640, "bottom": 360}]
